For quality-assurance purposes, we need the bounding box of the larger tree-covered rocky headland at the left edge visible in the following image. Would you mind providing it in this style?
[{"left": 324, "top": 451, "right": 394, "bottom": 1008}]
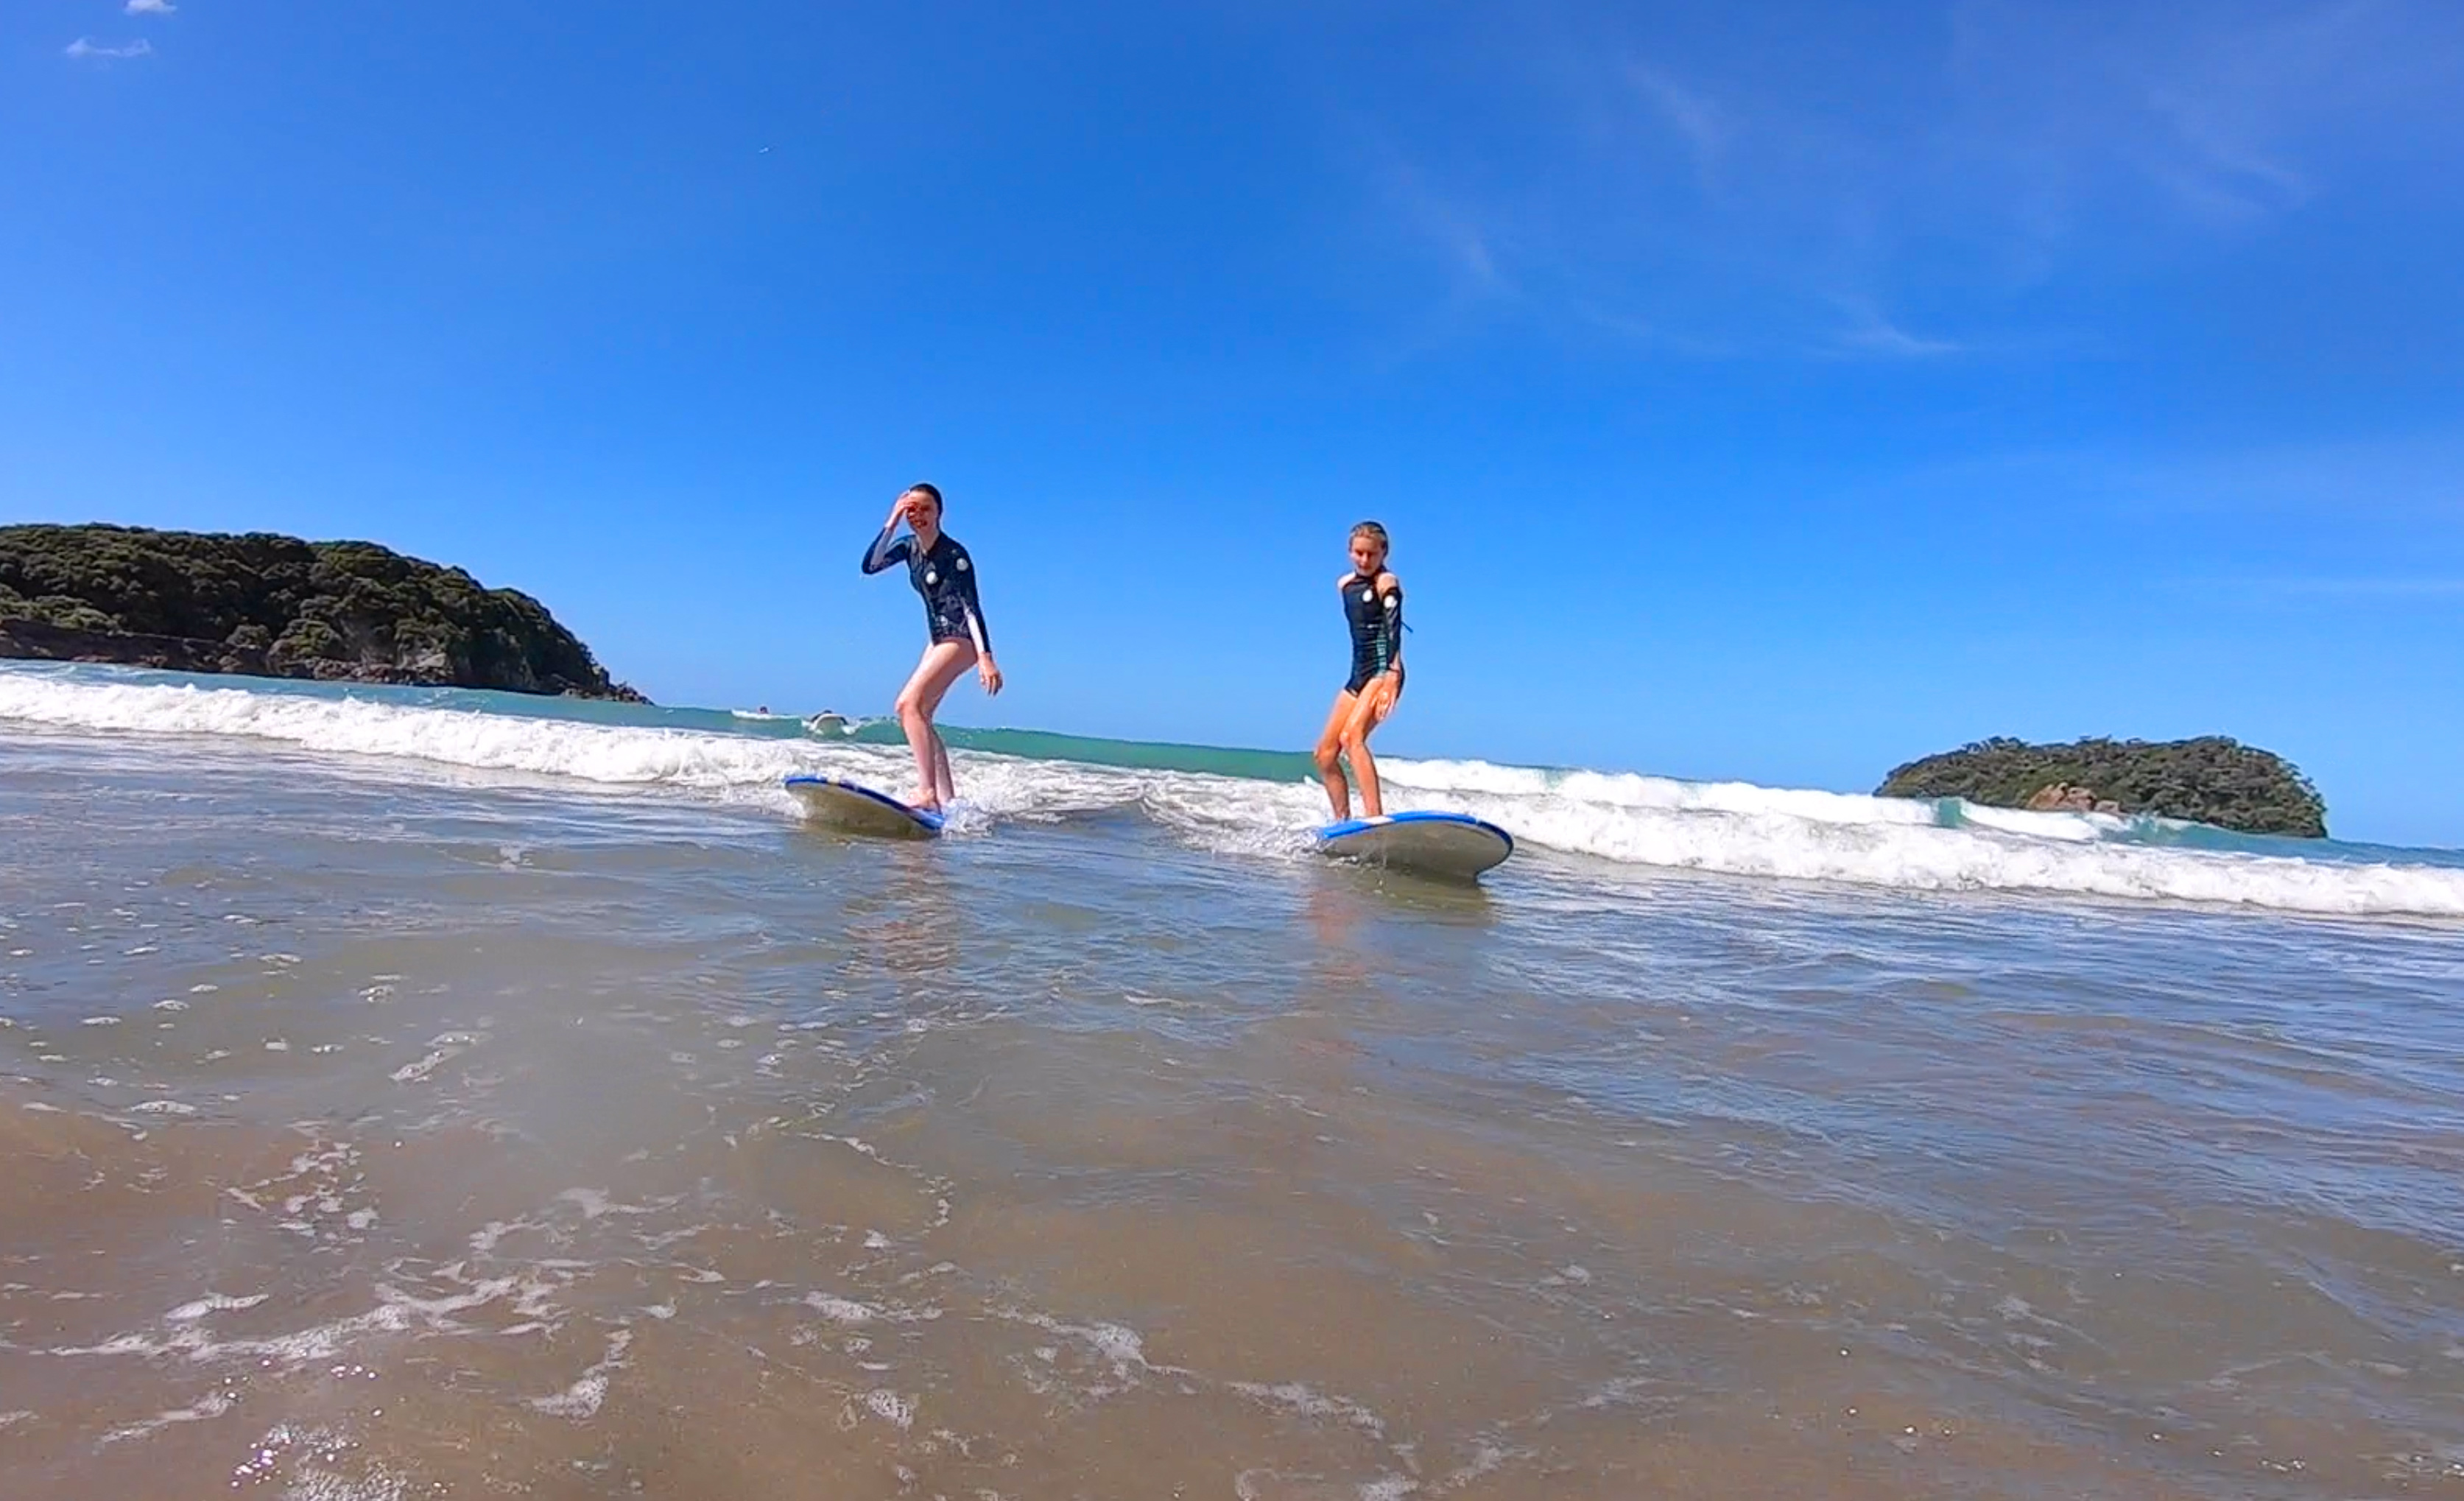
[{"left": 0, "top": 525, "right": 648, "bottom": 703}]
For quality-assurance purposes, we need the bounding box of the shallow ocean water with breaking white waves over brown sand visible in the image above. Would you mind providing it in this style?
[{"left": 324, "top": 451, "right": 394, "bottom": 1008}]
[{"left": 0, "top": 663, "right": 2464, "bottom": 1501}]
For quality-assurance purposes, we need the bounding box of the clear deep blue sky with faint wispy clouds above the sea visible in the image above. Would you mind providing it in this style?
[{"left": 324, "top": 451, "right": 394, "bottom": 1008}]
[{"left": 14, "top": 0, "right": 2464, "bottom": 843}]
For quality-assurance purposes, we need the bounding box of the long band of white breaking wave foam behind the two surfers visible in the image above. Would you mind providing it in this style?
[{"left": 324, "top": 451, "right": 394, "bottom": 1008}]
[{"left": 0, "top": 670, "right": 2464, "bottom": 916}]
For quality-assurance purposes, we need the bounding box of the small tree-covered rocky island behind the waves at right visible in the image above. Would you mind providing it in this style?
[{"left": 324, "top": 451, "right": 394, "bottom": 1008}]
[{"left": 1875, "top": 734, "right": 2326, "bottom": 838}]
